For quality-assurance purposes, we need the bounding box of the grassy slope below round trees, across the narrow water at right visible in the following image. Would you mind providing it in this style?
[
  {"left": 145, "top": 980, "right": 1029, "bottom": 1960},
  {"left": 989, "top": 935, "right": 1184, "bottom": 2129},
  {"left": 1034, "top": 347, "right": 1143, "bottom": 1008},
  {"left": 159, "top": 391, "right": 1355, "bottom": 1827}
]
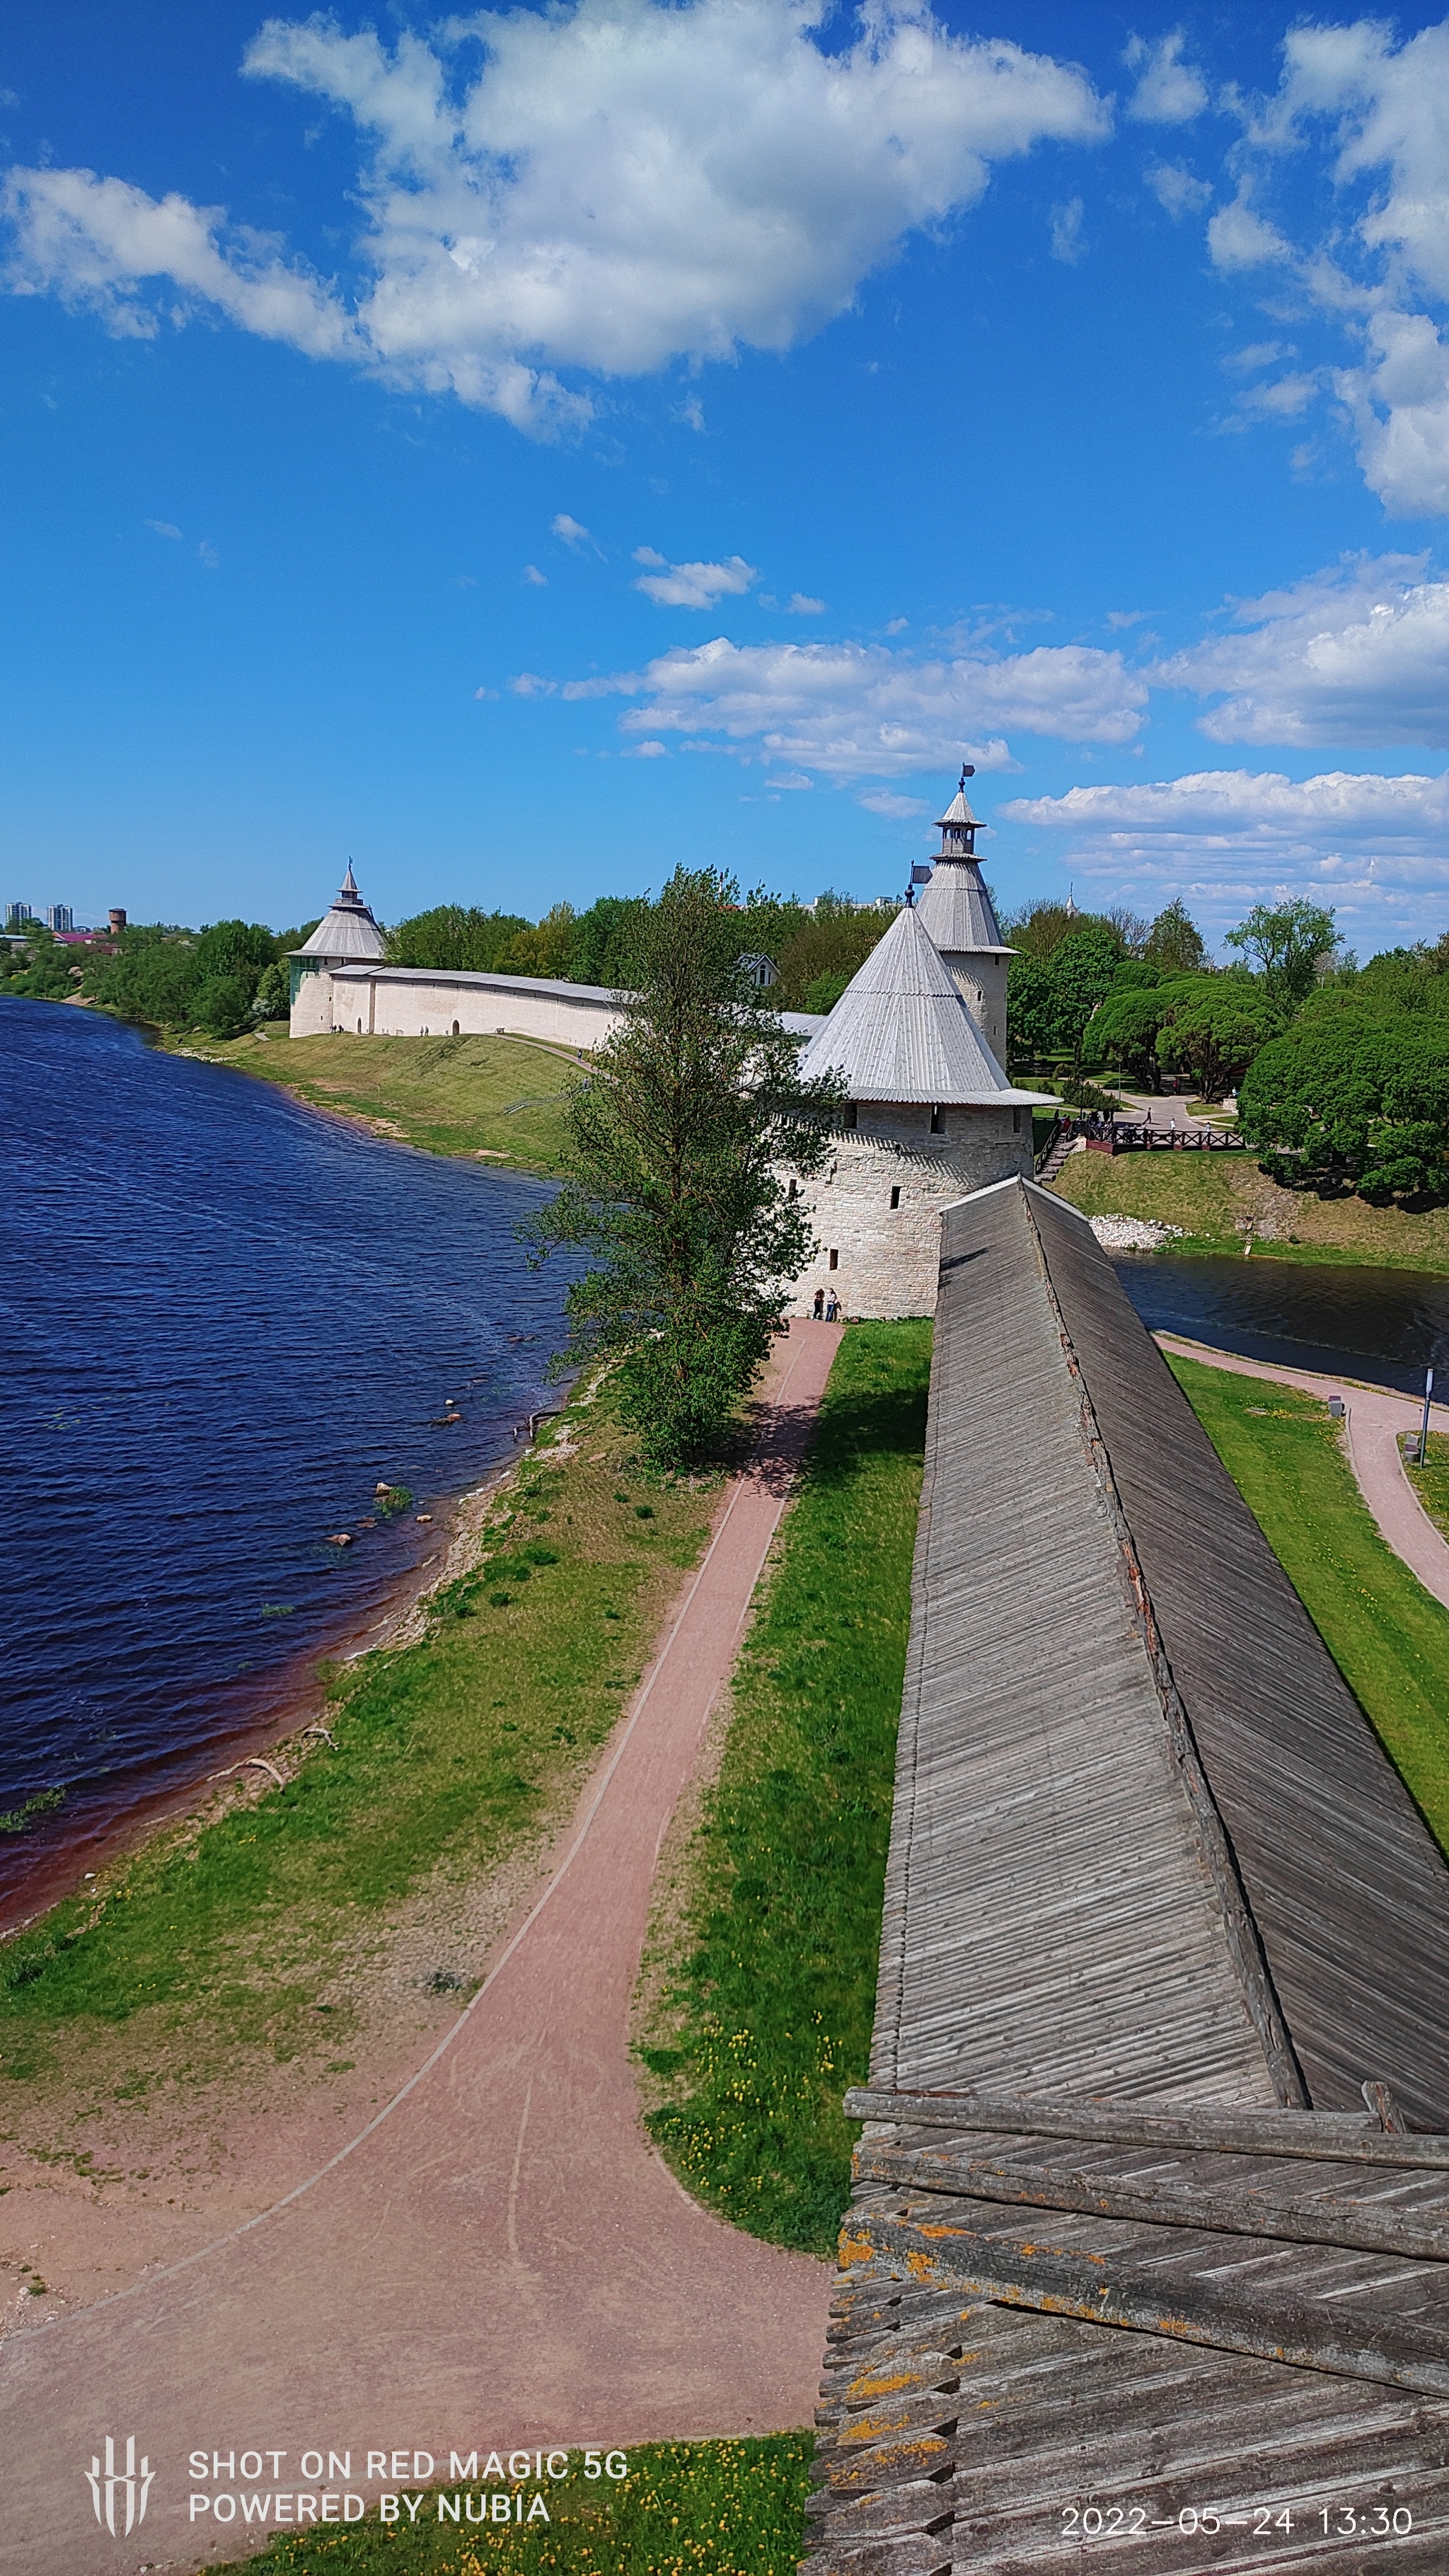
[{"left": 1041, "top": 1154, "right": 1449, "bottom": 1270}]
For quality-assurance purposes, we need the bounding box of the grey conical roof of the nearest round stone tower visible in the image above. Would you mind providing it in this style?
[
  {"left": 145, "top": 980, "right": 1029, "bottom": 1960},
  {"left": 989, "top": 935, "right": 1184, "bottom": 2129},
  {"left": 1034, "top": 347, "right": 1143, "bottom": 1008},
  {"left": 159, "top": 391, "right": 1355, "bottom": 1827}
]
[{"left": 799, "top": 904, "right": 1047, "bottom": 1108}]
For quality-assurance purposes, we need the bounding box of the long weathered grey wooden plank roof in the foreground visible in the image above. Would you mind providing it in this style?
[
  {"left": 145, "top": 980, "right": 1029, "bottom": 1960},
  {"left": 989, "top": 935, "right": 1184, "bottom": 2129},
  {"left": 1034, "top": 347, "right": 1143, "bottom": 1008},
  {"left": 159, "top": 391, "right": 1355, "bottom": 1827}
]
[{"left": 807, "top": 1182, "right": 1449, "bottom": 2576}]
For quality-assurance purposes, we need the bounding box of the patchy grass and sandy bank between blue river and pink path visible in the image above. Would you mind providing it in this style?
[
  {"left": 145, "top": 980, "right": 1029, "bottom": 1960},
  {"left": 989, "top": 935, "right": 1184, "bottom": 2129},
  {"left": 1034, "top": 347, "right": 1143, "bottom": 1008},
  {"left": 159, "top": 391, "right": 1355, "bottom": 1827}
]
[{"left": 0, "top": 1402, "right": 712, "bottom": 2323}]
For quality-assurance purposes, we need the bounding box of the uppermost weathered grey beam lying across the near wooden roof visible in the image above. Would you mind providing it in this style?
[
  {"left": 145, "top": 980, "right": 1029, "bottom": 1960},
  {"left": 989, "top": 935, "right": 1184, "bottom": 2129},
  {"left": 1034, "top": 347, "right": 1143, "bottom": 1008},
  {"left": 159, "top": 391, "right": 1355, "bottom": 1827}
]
[{"left": 845, "top": 2084, "right": 1449, "bottom": 2171}]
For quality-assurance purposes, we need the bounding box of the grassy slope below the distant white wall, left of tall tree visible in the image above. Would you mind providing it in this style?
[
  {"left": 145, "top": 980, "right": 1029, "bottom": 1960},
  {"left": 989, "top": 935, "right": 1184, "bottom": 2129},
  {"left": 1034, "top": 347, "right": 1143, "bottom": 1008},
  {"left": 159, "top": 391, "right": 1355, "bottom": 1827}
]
[{"left": 183, "top": 1025, "right": 577, "bottom": 1172}]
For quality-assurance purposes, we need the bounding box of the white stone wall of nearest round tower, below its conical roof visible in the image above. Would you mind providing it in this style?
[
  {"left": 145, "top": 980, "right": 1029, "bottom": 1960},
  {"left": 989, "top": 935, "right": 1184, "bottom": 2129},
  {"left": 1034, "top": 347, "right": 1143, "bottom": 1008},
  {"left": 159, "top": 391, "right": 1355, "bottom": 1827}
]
[{"left": 789, "top": 1102, "right": 1032, "bottom": 1319}]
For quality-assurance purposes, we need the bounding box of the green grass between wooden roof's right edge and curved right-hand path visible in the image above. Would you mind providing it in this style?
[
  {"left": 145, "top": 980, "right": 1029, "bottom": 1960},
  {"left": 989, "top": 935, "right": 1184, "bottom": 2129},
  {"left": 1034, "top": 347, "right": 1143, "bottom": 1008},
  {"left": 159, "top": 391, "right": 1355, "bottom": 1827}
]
[{"left": 1168, "top": 1355, "right": 1449, "bottom": 1852}]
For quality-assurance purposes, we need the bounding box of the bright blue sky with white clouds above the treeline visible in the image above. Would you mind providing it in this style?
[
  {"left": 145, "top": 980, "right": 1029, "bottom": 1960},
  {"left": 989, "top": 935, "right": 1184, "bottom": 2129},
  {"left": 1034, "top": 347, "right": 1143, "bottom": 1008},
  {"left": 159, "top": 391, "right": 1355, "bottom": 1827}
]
[{"left": 0, "top": 0, "right": 1449, "bottom": 956}]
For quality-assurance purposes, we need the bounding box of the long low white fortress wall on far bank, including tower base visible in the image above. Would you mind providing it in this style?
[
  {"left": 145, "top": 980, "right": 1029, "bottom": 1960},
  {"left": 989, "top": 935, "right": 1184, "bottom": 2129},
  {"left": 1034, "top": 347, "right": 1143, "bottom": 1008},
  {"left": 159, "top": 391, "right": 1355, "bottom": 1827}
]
[{"left": 291, "top": 966, "right": 619, "bottom": 1049}]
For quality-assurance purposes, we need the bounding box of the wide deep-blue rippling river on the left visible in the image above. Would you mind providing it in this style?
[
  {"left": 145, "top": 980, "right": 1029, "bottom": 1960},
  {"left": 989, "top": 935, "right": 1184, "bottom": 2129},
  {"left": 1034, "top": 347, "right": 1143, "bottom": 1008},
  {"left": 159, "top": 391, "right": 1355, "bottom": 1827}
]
[{"left": 0, "top": 1002, "right": 565, "bottom": 1901}]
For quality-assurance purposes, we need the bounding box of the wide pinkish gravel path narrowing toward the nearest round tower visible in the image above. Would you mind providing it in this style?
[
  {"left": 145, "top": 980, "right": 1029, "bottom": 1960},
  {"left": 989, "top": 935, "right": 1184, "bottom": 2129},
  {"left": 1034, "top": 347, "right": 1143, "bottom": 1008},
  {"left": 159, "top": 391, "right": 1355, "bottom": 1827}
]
[{"left": 0, "top": 1322, "right": 841, "bottom": 2576}]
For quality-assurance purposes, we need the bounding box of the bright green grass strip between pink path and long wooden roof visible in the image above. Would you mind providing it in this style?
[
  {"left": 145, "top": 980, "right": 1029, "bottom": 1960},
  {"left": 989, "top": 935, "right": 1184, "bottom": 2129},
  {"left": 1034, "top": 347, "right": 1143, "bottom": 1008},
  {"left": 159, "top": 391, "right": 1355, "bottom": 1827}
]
[{"left": 640, "top": 1324, "right": 931, "bottom": 2254}]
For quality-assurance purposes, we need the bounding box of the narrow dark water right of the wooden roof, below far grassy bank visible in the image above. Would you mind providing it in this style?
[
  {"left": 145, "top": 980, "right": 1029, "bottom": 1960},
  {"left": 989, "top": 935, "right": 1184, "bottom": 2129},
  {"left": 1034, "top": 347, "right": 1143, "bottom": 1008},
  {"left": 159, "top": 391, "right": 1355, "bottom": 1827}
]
[{"left": 1116, "top": 1252, "right": 1449, "bottom": 1394}]
